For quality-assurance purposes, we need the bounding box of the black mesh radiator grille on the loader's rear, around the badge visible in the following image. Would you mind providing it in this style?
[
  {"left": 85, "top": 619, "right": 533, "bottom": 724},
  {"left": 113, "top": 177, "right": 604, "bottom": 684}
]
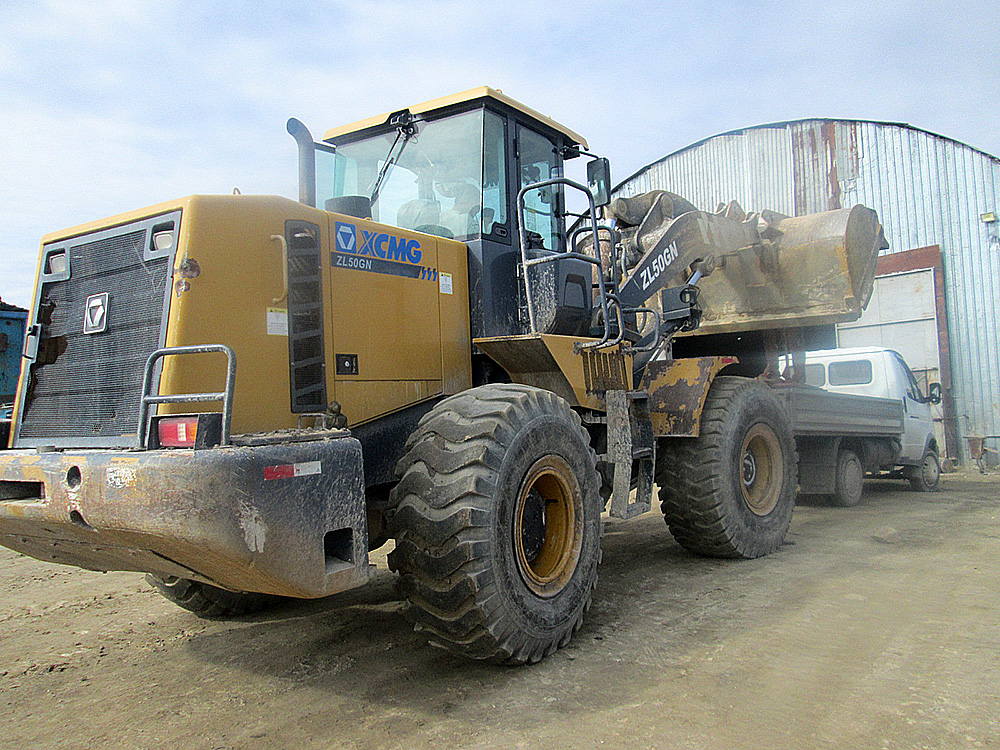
[{"left": 19, "top": 219, "right": 171, "bottom": 445}]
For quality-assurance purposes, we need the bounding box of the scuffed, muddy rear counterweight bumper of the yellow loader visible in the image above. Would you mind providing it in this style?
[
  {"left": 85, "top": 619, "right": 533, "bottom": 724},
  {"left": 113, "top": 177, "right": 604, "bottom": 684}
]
[{"left": 0, "top": 432, "right": 368, "bottom": 598}]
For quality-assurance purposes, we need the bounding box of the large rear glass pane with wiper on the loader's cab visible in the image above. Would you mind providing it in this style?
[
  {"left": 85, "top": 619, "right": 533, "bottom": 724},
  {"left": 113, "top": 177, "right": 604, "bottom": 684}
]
[{"left": 316, "top": 109, "right": 507, "bottom": 239}]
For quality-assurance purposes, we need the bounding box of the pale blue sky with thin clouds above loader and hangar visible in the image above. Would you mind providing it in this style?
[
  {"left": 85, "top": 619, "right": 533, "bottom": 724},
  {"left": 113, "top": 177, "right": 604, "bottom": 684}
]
[{"left": 0, "top": 0, "right": 1000, "bottom": 307}]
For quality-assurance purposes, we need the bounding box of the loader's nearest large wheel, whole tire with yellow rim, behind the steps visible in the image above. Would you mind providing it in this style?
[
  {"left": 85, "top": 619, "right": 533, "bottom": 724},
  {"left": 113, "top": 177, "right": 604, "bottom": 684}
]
[{"left": 389, "top": 384, "right": 602, "bottom": 664}]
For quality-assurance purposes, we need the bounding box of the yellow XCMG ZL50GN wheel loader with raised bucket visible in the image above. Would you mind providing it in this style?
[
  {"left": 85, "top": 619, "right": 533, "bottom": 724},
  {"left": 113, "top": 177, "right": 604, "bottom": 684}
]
[{"left": 0, "top": 87, "right": 899, "bottom": 664}]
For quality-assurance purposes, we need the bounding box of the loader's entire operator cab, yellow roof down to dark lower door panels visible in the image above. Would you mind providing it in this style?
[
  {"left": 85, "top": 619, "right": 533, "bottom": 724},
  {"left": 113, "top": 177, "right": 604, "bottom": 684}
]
[{"left": 289, "top": 86, "right": 592, "bottom": 344}]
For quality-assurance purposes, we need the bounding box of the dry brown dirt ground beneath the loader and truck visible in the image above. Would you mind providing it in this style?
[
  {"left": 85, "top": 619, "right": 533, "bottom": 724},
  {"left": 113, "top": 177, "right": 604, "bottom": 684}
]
[{"left": 0, "top": 474, "right": 1000, "bottom": 750}]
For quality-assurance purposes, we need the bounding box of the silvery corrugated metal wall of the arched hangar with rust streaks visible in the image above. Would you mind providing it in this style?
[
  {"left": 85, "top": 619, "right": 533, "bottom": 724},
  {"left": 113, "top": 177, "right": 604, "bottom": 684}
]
[{"left": 616, "top": 120, "right": 1000, "bottom": 457}]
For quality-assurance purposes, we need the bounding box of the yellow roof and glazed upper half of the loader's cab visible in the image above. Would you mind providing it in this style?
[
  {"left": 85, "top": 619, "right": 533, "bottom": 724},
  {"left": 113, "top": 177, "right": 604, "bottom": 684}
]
[{"left": 316, "top": 86, "right": 586, "bottom": 251}]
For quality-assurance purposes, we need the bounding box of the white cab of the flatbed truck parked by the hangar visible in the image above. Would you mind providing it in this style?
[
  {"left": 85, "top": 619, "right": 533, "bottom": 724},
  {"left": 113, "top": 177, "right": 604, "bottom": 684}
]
[{"left": 792, "top": 347, "right": 941, "bottom": 500}]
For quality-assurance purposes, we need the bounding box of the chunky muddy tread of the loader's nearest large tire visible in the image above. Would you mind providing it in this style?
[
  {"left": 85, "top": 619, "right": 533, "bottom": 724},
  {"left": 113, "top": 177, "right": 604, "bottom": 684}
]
[{"left": 389, "top": 383, "right": 597, "bottom": 664}]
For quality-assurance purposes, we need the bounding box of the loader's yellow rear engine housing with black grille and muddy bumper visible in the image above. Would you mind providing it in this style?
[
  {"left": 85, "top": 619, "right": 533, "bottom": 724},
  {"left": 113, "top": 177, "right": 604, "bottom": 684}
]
[{"left": 0, "top": 196, "right": 471, "bottom": 597}]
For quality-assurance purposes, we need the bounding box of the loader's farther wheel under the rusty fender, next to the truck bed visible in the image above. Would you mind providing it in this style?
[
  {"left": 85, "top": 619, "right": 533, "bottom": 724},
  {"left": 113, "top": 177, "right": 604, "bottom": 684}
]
[{"left": 657, "top": 376, "right": 796, "bottom": 558}]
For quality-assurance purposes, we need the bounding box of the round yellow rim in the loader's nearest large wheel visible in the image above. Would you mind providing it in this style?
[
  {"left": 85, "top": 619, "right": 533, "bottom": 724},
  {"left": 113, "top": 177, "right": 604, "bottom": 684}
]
[{"left": 513, "top": 456, "right": 583, "bottom": 598}]
